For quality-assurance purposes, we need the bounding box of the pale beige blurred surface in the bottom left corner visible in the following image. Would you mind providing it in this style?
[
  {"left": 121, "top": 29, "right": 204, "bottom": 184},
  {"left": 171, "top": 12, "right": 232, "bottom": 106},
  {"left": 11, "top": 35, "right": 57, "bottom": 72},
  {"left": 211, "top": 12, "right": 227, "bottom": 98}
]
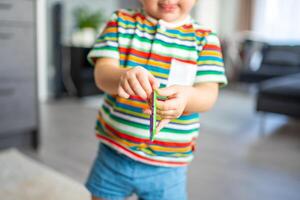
[{"left": 0, "top": 149, "right": 90, "bottom": 200}]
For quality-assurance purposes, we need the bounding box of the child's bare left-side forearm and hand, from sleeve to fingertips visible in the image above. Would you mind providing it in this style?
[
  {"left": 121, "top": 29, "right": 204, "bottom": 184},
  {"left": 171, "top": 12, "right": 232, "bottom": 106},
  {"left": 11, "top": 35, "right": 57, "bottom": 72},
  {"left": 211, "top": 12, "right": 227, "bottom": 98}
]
[{"left": 94, "top": 58, "right": 159, "bottom": 99}]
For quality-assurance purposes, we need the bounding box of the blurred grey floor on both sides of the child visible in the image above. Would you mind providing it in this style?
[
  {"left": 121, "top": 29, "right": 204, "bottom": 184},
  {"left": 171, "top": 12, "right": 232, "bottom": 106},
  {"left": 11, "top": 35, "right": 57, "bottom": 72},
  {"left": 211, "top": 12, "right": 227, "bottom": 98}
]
[{"left": 26, "top": 88, "right": 300, "bottom": 200}]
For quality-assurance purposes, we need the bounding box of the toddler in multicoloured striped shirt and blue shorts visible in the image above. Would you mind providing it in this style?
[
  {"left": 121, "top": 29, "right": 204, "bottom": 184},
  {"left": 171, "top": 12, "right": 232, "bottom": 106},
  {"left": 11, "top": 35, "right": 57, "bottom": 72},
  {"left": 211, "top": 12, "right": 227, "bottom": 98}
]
[{"left": 86, "top": 0, "right": 227, "bottom": 200}]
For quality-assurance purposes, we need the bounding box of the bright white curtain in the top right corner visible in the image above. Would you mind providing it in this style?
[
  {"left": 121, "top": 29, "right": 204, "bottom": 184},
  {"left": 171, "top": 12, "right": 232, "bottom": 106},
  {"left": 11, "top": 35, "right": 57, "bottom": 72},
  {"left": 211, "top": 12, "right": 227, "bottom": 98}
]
[{"left": 252, "top": 0, "right": 300, "bottom": 42}]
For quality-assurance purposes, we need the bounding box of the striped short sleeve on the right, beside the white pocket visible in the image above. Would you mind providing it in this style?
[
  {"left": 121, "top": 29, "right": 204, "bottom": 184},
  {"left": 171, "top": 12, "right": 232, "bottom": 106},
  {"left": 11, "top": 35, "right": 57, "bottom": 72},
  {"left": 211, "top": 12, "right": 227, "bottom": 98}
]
[{"left": 195, "top": 33, "right": 227, "bottom": 86}]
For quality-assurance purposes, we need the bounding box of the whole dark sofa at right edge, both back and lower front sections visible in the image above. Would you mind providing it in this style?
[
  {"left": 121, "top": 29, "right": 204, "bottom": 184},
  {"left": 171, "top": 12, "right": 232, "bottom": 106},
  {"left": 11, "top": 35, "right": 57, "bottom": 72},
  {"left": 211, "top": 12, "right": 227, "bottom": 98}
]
[{"left": 239, "top": 40, "right": 300, "bottom": 118}]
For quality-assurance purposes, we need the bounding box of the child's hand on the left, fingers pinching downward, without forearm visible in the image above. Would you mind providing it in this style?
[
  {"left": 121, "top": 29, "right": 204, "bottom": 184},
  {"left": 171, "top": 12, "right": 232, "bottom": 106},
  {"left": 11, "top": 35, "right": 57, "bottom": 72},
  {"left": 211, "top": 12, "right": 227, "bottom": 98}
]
[{"left": 118, "top": 67, "right": 159, "bottom": 100}]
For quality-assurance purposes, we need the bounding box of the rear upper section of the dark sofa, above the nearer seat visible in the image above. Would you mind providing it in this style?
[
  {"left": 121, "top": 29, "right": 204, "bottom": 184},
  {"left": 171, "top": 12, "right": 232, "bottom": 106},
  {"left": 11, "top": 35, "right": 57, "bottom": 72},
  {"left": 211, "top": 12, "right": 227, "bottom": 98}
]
[{"left": 239, "top": 41, "right": 300, "bottom": 83}]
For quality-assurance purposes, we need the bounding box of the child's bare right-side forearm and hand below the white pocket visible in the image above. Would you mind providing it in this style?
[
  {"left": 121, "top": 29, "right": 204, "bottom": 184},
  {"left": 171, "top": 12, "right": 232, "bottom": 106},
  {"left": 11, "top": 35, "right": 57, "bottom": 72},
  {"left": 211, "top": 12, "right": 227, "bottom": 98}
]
[{"left": 145, "top": 83, "right": 219, "bottom": 132}]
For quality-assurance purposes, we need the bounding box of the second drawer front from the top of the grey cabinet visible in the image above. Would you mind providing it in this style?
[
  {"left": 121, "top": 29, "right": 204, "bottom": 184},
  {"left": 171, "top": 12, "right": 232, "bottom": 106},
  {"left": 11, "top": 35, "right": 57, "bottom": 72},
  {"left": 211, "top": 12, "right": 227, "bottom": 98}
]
[{"left": 0, "top": 25, "right": 36, "bottom": 78}]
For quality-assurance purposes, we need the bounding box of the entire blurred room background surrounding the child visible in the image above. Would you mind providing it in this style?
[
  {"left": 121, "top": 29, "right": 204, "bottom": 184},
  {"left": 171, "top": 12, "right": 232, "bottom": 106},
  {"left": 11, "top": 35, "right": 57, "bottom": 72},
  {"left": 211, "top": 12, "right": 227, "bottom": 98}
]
[{"left": 0, "top": 0, "right": 300, "bottom": 200}]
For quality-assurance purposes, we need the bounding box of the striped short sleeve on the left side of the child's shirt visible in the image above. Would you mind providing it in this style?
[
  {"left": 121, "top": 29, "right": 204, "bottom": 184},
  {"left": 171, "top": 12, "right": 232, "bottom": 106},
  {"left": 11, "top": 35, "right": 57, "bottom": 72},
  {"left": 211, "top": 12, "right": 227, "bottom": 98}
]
[{"left": 87, "top": 12, "right": 119, "bottom": 65}]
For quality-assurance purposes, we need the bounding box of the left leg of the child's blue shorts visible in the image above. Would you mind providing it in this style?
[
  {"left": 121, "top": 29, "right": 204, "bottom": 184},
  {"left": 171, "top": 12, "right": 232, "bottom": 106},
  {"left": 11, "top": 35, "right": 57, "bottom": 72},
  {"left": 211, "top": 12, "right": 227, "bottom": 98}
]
[{"left": 85, "top": 144, "right": 133, "bottom": 200}]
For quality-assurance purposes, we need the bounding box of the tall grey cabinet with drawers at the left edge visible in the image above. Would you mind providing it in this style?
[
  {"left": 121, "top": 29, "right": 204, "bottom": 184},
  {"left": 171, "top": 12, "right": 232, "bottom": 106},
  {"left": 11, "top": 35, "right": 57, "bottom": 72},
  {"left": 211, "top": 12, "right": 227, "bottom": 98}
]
[{"left": 0, "top": 0, "right": 39, "bottom": 149}]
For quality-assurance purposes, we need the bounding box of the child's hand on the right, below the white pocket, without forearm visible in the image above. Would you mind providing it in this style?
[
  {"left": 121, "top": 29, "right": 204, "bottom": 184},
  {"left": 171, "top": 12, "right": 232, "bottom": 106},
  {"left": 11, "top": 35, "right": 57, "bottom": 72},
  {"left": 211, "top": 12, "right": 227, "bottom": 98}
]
[{"left": 145, "top": 85, "right": 189, "bottom": 133}]
